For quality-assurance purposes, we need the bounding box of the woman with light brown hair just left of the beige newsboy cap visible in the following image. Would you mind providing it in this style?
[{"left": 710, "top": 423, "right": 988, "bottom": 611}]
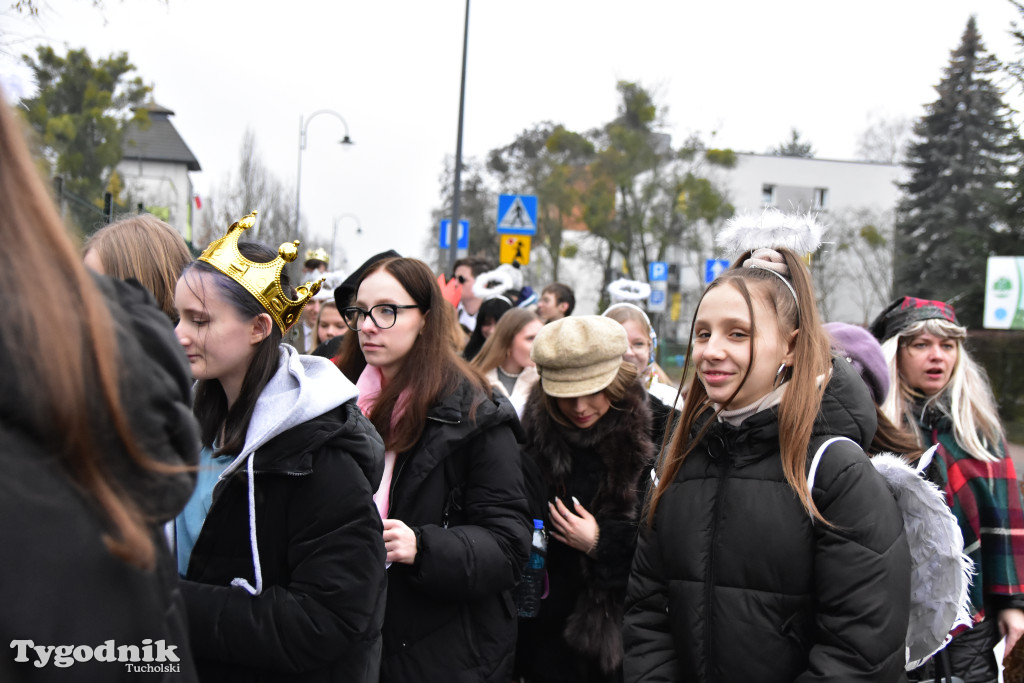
[{"left": 471, "top": 303, "right": 544, "bottom": 417}]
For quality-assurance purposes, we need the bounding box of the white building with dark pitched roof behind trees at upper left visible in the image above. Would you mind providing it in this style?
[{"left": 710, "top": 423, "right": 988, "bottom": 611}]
[{"left": 117, "top": 102, "right": 202, "bottom": 242}]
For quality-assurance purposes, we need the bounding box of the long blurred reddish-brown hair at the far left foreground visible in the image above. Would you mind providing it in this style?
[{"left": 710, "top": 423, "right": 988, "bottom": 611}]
[{"left": 0, "top": 90, "right": 169, "bottom": 568}]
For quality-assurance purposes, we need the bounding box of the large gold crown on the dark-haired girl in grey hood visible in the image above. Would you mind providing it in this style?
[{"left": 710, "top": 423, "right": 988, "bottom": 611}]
[{"left": 199, "top": 211, "right": 324, "bottom": 334}]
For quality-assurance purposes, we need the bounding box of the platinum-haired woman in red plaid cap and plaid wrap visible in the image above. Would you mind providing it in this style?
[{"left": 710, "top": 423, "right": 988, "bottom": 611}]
[{"left": 871, "top": 297, "right": 1024, "bottom": 683}]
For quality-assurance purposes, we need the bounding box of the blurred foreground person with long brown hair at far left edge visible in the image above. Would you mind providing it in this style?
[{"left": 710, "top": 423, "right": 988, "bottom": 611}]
[{"left": 0, "top": 87, "right": 199, "bottom": 681}]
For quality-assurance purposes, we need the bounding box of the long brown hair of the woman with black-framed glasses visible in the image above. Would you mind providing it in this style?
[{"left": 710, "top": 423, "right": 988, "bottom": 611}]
[{"left": 337, "top": 258, "right": 492, "bottom": 453}]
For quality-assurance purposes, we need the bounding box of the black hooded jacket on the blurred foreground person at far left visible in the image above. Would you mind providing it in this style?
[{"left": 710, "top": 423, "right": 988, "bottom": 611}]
[{"left": 0, "top": 276, "right": 199, "bottom": 683}]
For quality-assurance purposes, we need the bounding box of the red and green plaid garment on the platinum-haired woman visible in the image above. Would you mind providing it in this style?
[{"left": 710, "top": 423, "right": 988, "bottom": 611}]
[{"left": 921, "top": 411, "right": 1024, "bottom": 624}]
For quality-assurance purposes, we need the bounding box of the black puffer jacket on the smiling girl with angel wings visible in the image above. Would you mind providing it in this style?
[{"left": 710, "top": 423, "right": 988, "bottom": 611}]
[{"left": 625, "top": 362, "right": 910, "bottom": 683}]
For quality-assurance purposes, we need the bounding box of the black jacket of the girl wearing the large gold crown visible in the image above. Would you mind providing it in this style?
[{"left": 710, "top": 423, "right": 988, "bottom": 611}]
[{"left": 182, "top": 401, "right": 386, "bottom": 683}]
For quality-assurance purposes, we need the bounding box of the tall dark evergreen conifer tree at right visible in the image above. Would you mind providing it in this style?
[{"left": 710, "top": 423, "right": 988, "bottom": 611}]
[{"left": 894, "top": 16, "right": 1016, "bottom": 328}]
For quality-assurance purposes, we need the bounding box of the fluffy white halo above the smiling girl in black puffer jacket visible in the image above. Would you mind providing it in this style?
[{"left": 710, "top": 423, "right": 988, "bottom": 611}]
[{"left": 715, "top": 208, "right": 824, "bottom": 255}]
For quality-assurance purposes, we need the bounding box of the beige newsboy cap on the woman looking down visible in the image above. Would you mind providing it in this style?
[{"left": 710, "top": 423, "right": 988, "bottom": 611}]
[{"left": 529, "top": 315, "right": 628, "bottom": 398}]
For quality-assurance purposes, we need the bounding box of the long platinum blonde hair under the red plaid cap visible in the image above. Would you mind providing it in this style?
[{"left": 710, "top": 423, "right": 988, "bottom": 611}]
[{"left": 882, "top": 318, "right": 1004, "bottom": 462}]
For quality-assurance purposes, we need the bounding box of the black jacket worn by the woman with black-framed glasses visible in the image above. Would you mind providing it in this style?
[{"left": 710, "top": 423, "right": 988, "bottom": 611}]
[{"left": 381, "top": 382, "right": 532, "bottom": 683}]
